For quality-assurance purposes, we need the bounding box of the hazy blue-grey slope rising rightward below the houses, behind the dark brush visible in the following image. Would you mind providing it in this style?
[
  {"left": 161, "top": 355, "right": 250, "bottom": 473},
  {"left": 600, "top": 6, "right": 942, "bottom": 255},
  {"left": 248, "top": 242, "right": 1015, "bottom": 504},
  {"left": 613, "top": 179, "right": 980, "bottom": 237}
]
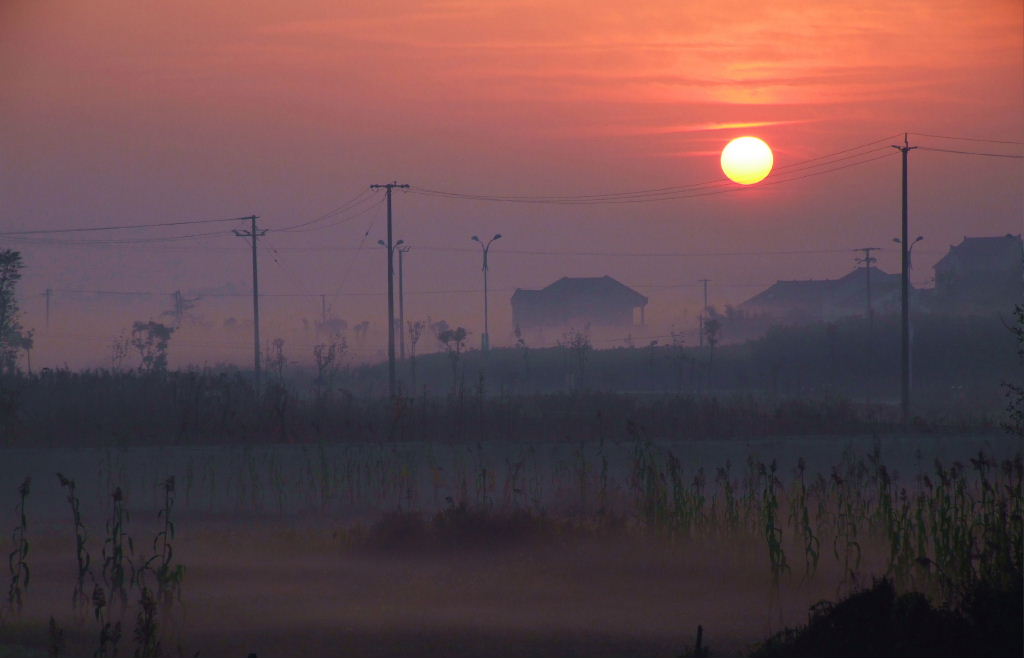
[{"left": 344, "top": 314, "right": 1022, "bottom": 413}]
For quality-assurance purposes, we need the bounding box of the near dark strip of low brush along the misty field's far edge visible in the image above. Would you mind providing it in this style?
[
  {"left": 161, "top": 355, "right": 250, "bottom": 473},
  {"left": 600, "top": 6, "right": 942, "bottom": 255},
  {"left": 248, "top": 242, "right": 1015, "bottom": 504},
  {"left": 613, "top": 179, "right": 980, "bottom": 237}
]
[{"left": 0, "top": 369, "right": 995, "bottom": 447}]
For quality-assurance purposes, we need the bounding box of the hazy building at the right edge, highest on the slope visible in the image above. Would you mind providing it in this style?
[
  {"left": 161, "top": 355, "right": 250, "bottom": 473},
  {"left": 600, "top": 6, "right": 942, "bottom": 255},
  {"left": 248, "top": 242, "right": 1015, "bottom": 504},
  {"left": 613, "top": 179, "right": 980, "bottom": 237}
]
[{"left": 935, "top": 233, "right": 1024, "bottom": 311}]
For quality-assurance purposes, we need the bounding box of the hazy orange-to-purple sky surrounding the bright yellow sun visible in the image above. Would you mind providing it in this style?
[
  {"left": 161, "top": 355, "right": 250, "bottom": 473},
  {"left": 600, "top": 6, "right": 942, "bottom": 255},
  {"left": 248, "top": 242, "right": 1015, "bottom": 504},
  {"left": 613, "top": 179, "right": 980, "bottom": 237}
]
[{"left": 0, "top": 0, "right": 1024, "bottom": 366}]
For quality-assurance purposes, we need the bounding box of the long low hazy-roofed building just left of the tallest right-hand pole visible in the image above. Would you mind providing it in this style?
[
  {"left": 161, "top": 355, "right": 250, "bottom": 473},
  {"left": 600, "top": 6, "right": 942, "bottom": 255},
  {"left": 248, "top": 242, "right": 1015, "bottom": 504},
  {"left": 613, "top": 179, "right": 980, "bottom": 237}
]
[{"left": 739, "top": 267, "right": 900, "bottom": 322}]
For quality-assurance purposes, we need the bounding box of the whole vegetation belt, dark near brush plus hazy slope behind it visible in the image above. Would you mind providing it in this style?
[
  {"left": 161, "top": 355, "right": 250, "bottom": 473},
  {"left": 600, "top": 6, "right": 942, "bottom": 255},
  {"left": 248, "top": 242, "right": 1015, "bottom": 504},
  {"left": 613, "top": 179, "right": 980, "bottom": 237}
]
[{"left": 0, "top": 317, "right": 1007, "bottom": 446}]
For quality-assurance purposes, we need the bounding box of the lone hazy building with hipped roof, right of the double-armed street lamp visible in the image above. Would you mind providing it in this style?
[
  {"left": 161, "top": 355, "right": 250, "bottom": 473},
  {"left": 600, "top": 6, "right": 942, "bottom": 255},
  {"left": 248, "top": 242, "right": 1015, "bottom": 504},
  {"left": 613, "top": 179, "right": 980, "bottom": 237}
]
[{"left": 512, "top": 276, "right": 647, "bottom": 331}]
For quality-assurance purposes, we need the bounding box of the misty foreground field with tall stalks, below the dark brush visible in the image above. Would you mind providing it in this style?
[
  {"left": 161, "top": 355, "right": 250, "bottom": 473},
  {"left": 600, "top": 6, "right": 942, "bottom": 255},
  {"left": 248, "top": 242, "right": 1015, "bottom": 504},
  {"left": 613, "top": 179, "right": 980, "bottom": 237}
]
[{"left": 0, "top": 435, "right": 1022, "bottom": 657}]
